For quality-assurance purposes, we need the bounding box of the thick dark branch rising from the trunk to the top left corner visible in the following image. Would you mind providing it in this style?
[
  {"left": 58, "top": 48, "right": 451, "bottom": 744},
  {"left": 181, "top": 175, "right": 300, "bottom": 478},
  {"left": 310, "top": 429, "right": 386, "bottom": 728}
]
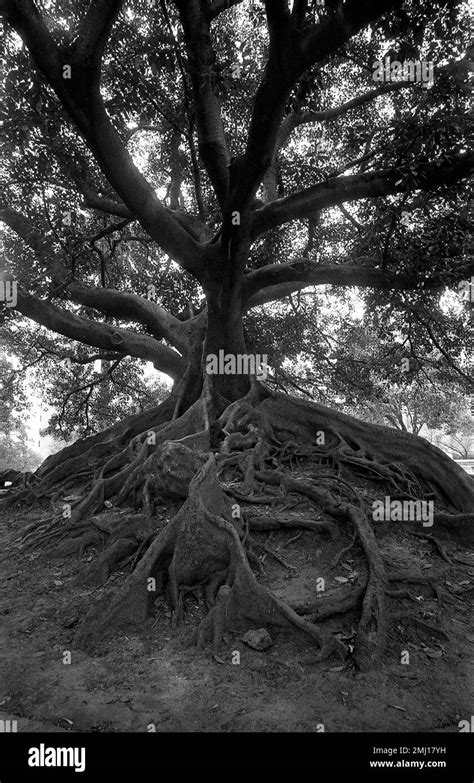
[{"left": 0, "top": 0, "right": 203, "bottom": 279}]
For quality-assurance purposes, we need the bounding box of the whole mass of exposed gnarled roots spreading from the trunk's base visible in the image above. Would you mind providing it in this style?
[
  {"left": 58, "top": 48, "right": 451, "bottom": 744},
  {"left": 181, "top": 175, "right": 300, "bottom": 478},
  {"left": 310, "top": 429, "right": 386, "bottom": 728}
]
[{"left": 2, "top": 382, "right": 474, "bottom": 670}]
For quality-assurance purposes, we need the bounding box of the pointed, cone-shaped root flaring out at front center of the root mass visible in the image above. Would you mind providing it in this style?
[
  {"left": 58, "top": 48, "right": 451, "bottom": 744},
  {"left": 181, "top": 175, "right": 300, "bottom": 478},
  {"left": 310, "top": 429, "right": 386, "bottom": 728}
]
[{"left": 76, "top": 455, "right": 343, "bottom": 657}]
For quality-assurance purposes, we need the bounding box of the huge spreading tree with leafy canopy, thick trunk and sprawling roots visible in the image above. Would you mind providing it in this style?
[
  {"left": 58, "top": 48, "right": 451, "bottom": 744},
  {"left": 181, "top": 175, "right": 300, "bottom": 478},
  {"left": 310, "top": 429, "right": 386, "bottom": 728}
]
[{"left": 1, "top": 0, "right": 474, "bottom": 668}]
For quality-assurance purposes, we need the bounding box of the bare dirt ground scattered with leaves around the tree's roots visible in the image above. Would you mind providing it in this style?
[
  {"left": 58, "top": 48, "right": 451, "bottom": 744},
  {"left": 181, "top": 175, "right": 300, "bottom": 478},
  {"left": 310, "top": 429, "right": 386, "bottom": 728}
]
[{"left": 0, "top": 484, "right": 474, "bottom": 732}]
